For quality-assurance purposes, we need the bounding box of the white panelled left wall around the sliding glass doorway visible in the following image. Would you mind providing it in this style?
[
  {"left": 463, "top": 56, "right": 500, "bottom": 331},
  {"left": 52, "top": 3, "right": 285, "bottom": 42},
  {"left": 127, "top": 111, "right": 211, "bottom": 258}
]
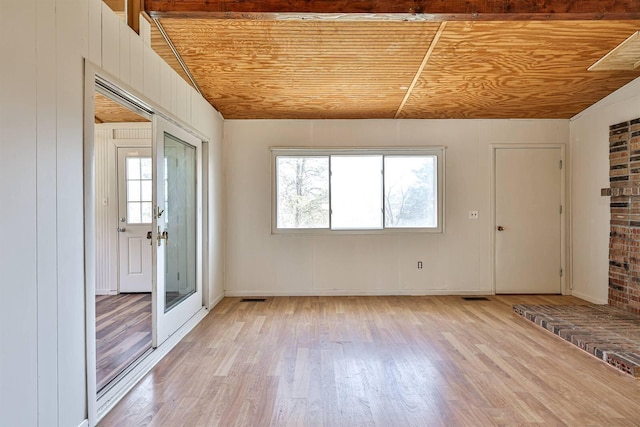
[{"left": 0, "top": 0, "right": 223, "bottom": 427}]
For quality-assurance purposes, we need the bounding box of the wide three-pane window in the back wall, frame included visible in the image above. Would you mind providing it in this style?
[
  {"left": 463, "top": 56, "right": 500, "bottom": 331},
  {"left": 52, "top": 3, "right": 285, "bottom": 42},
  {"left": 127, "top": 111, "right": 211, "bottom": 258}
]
[{"left": 272, "top": 147, "right": 444, "bottom": 233}]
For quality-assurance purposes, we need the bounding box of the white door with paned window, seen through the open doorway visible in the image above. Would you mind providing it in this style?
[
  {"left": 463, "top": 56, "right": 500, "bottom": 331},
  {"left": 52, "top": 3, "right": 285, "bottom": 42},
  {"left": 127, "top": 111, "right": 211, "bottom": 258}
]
[{"left": 117, "top": 147, "right": 153, "bottom": 293}]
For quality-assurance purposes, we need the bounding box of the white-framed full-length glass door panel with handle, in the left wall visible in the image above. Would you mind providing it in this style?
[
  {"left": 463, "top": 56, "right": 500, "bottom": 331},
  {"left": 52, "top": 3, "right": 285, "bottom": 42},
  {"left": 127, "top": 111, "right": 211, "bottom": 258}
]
[{"left": 153, "top": 117, "right": 203, "bottom": 346}]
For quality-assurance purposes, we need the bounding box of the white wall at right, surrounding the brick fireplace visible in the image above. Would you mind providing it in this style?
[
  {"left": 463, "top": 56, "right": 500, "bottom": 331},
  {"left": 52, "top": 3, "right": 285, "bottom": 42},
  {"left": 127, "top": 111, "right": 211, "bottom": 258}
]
[{"left": 570, "top": 79, "right": 640, "bottom": 304}]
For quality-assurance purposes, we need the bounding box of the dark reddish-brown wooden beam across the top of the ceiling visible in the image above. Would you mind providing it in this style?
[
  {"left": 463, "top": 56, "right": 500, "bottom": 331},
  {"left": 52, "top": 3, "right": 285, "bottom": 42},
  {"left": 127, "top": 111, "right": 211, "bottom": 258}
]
[{"left": 144, "top": 0, "right": 640, "bottom": 21}]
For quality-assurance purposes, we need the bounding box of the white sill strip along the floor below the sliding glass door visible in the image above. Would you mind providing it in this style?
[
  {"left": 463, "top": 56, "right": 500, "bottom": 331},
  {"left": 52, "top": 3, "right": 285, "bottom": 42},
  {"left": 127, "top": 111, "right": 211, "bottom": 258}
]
[{"left": 96, "top": 307, "right": 209, "bottom": 423}]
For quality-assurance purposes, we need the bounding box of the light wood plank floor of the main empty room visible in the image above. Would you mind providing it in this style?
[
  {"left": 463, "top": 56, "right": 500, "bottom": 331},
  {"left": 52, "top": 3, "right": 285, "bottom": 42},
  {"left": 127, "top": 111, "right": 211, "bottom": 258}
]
[{"left": 100, "top": 296, "right": 640, "bottom": 427}]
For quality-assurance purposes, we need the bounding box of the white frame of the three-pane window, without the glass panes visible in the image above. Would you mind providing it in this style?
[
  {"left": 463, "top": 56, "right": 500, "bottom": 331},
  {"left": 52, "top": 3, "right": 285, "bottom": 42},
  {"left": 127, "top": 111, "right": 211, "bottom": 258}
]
[{"left": 270, "top": 146, "right": 446, "bottom": 235}]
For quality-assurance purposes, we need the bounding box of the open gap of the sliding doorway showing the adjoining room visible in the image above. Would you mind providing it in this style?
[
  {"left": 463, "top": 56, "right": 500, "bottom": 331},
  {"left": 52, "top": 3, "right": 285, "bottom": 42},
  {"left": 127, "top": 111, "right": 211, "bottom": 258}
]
[{"left": 94, "top": 86, "right": 153, "bottom": 397}]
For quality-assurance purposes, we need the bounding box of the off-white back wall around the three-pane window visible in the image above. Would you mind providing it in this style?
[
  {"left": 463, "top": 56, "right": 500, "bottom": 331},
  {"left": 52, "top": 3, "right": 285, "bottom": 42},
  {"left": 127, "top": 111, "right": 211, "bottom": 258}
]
[{"left": 223, "top": 120, "right": 569, "bottom": 296}]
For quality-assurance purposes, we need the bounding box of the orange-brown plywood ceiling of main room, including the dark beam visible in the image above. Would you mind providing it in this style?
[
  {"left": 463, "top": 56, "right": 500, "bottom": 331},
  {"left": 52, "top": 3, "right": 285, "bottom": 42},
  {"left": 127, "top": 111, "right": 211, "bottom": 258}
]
[{"left": 145, "top": 0, "right": 640, "bottom": 119}]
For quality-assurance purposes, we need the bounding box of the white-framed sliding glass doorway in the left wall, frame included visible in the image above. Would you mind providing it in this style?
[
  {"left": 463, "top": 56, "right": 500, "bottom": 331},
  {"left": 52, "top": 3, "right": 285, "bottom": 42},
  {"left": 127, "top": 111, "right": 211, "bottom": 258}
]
[{"left": 84, "top": 70, "right": 208, "bottom": 425}]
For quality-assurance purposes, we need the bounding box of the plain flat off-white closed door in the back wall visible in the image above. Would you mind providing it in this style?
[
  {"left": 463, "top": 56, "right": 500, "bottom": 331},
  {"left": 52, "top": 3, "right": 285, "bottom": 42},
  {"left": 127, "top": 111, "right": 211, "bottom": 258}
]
[{"left": 494, "top": 148, "right": 563, "bottom": 294}]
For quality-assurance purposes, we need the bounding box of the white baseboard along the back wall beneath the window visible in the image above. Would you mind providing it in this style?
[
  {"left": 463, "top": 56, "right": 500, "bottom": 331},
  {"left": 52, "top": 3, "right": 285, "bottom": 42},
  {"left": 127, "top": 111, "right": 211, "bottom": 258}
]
[{"left": 224, "top": 289, "right": 493, "bottom": 298}]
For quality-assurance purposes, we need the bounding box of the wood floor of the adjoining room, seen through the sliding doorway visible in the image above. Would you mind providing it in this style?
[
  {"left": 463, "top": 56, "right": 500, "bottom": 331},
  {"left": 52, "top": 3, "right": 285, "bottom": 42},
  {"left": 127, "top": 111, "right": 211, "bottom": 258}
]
[{"left": 96, "top": 294, "right": 151, "bottom": 392}]
